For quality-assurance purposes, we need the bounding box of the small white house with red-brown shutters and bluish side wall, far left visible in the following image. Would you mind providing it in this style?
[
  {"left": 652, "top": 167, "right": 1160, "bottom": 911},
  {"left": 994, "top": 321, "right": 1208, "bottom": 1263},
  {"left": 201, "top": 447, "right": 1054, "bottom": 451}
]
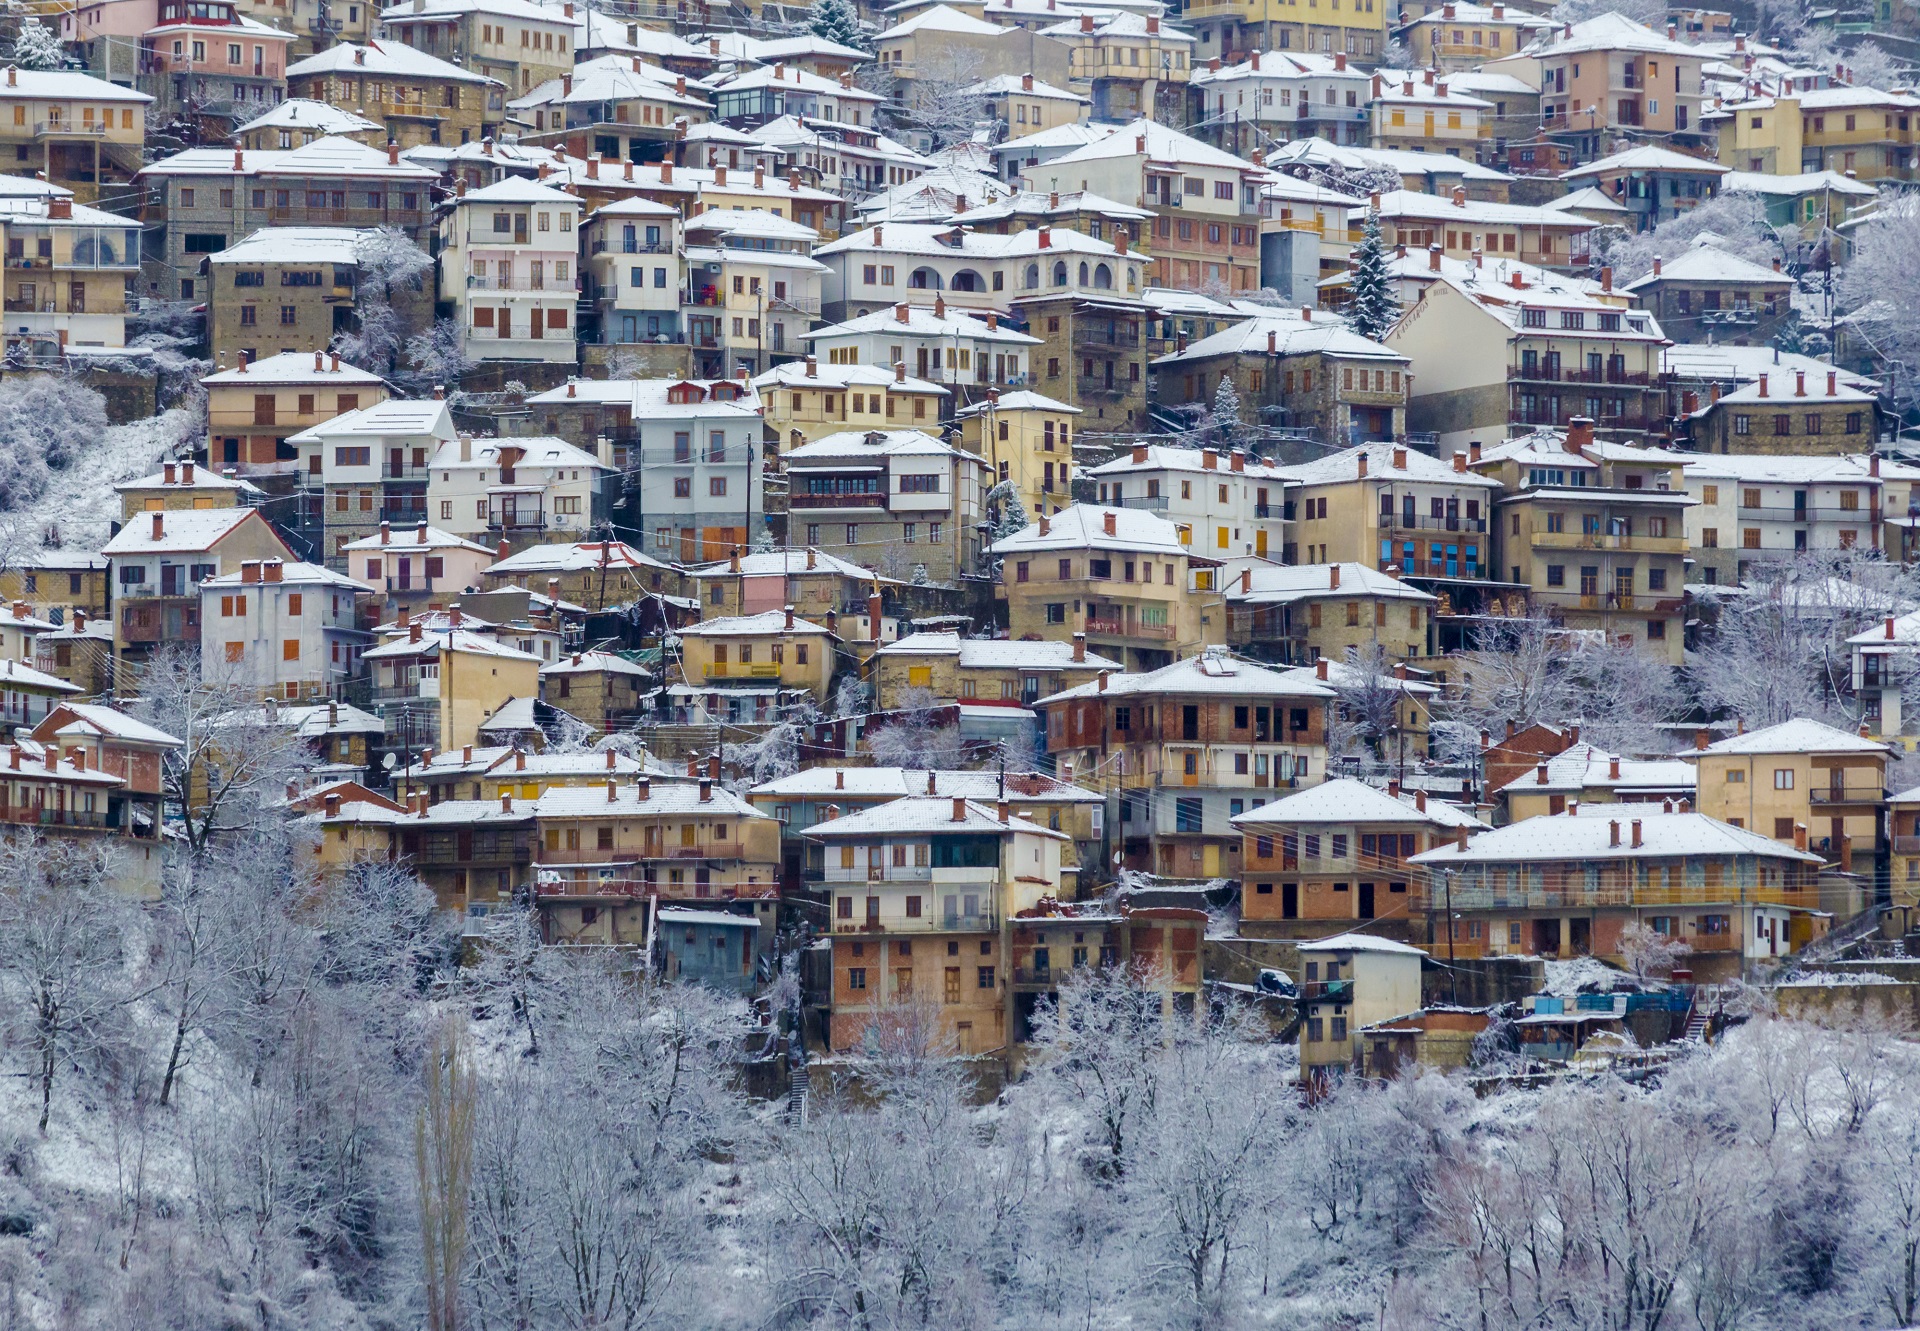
[{"left": 200, "top": 559, "right": 374, "bottom": 699}]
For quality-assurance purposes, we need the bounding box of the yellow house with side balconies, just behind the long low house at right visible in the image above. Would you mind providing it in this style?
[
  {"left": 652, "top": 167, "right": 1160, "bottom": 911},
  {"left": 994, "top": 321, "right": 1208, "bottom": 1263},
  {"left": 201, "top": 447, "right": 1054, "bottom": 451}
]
[{"left": 1688, "top": 718, "right": 1887, "bottom": 882}]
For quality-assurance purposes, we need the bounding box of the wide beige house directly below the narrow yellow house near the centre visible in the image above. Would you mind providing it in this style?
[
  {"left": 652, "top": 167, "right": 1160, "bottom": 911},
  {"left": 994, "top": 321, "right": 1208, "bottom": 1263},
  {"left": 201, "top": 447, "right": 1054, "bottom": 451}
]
[{"left": 989, "top": 503, "right": 1227, "bottom": 670}]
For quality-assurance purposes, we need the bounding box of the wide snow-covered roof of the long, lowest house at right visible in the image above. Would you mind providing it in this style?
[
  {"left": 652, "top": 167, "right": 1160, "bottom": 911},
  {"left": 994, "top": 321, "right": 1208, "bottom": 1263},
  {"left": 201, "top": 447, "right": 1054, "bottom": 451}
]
[{"left": 1411, "top": 805, "right": 1820, "bottom": 868}]
